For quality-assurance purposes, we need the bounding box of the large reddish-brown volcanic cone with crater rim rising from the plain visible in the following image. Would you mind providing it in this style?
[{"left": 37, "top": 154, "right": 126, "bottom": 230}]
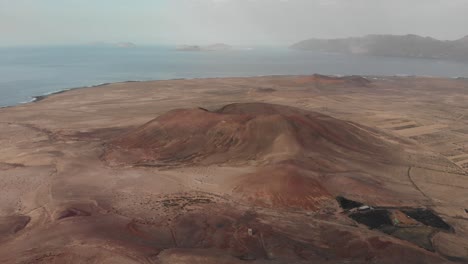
[{"left": 104, "top": 103, "right": 398, "bottom": 168}]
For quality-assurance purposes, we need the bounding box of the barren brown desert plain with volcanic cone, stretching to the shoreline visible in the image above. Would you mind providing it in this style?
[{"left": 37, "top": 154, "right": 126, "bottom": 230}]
[{"left": 0, "top": 75, "right": 468, "bottom": 264}]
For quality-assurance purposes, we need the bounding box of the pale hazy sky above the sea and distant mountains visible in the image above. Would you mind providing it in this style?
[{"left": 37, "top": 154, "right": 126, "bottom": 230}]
[{"left": 0, "top": 0, "right": 468, "bottom": 45}]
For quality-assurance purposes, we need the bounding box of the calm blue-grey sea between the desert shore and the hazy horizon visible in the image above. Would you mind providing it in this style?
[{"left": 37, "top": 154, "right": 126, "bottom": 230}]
[{"left": 0, "top": 47, "right": 468, "bottom": 106}]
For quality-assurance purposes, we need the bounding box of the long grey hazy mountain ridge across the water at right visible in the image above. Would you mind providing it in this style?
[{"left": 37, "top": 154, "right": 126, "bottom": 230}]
[{"left": 290, "top": 35, "right": 468, "bottom": 60}]
